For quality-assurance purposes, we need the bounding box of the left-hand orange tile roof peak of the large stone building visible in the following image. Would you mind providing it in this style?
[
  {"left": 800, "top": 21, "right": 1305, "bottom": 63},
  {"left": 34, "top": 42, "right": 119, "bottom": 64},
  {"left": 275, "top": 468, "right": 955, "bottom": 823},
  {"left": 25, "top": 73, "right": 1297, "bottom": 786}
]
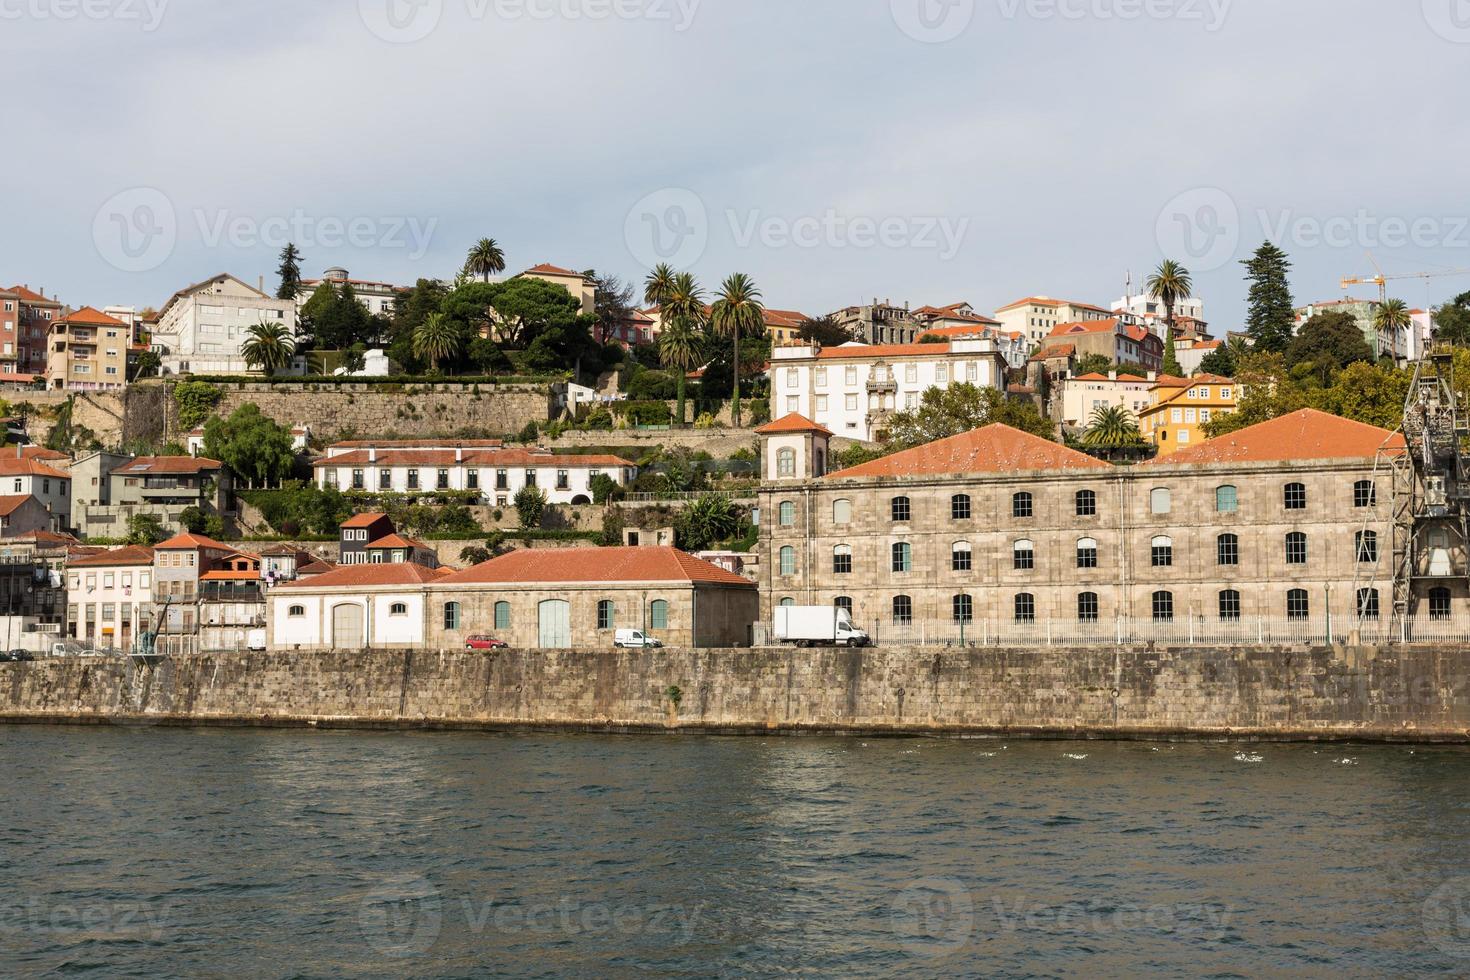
[{"left": 826, "top": 423, "right": 1111, "bottom": 480}]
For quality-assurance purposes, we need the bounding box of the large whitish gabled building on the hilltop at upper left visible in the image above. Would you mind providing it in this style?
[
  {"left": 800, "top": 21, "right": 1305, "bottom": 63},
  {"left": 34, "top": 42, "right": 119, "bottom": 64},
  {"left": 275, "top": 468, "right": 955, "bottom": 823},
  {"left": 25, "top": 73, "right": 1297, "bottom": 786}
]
[{"left": 153, "top": 273, "right": 297, "bottom": 375}]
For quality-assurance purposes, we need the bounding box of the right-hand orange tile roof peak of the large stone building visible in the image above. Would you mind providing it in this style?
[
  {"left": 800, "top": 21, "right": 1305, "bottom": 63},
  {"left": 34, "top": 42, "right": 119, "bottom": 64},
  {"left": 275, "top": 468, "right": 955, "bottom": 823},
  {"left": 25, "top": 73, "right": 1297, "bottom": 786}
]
[{"left": 1144, "top": 408, "right": 1407, "bottom": 466}]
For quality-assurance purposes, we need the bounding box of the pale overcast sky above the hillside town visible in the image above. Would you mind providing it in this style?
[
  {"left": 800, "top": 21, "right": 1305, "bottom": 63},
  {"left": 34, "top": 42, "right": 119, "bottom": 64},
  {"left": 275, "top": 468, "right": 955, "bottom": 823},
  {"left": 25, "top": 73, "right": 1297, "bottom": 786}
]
[{"left": 0, "top": 0, "right": 1470, "bottom": 332}]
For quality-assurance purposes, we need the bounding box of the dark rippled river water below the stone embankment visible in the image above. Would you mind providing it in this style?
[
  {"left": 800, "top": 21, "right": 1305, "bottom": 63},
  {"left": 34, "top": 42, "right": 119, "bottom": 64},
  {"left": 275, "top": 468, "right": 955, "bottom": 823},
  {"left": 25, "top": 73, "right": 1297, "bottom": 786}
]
[{"left": 0, "top": 727, "right": 1470, "bottom": 977}]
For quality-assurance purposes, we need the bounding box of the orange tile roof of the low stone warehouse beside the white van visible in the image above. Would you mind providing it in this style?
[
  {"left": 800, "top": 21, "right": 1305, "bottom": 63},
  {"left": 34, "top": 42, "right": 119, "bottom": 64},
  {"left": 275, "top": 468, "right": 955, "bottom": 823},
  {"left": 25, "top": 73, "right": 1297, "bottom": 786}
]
[{"left": 444, "top": 548, "right": 756, "bottom": 588}]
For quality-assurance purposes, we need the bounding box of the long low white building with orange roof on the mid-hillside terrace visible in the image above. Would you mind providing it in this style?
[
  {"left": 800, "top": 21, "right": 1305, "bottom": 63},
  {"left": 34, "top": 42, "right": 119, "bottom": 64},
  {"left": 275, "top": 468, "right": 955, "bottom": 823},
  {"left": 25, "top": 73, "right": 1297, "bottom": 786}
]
[{"left": 312, "top": 441, "right": 638, "bottom": 507}]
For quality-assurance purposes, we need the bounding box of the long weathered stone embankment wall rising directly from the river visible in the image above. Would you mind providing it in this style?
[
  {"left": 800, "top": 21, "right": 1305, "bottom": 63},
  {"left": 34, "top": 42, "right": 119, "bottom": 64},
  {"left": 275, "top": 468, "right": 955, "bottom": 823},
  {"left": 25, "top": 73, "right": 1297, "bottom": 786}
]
[{"left": 0, "top": 648, "right": 1470, "bottom": 742}]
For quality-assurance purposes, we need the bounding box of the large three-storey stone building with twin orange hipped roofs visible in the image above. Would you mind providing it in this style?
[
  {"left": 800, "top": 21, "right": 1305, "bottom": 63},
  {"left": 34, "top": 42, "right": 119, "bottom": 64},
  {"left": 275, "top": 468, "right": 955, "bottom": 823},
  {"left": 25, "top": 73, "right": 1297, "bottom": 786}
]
[{"left": 760, "top": 410, "right": 1411, "bottom": 642}]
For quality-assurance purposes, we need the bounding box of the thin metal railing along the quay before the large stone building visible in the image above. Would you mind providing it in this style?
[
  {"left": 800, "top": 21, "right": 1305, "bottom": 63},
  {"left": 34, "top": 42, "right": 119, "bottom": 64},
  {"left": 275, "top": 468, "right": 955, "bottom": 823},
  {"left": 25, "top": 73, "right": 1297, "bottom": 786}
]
[{"left": 751, "top": 613, "right": 1470, "bottom": 646}]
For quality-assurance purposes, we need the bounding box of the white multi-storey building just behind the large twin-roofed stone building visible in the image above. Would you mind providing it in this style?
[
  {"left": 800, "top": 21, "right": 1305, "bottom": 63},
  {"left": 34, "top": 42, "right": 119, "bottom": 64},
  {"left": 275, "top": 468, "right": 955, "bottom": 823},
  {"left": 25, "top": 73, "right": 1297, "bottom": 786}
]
[{"left": 770, "top": 339, "right": 1005, "bottom": 442}]
